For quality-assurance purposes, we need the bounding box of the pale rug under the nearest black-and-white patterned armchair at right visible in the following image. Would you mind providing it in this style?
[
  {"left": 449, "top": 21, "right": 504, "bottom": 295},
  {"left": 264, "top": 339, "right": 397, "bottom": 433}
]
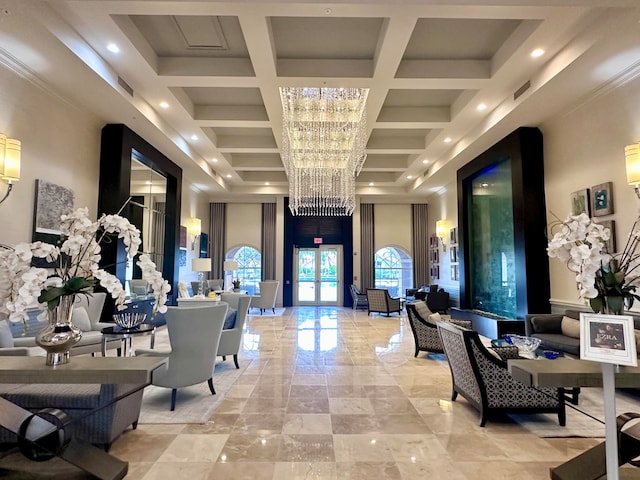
[{"left": 509, "top": 388, "right": 640, "bottom": 438}]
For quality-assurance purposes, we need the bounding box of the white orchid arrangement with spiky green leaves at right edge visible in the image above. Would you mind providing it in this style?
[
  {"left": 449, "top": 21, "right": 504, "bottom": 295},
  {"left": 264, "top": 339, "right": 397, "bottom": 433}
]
[{"left": 547, "top": 213, "right": 640, "bottom": 313}]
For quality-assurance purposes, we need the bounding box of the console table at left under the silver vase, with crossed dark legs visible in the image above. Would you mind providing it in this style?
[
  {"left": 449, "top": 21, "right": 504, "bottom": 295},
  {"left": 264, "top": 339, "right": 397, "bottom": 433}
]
[{"left": 0, "top": 357, "right": 167, "bottom": 480}]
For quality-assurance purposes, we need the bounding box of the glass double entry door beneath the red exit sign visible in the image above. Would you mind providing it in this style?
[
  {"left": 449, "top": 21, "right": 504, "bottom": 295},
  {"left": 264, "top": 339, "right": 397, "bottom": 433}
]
[{"left": 294, "top": 245, "right": 342, "bottom": 305}]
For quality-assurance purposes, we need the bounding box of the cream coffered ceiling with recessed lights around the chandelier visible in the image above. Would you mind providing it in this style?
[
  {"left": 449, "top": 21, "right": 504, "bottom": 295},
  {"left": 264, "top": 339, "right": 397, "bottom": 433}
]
[{"left": 0, "top": 0, "right": 640, "bottom": 198}]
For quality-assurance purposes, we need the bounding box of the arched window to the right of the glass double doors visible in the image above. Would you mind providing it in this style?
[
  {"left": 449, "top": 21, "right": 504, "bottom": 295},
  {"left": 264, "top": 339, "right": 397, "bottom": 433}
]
[{"left": 374, "top": 247, "right": 413, "bottom": 297}]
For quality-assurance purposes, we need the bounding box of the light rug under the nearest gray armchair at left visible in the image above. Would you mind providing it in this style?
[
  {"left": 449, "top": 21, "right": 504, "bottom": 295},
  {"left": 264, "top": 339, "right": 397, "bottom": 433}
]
[{"left": 139, "top": 356, "right": 251, "bottom": 423}]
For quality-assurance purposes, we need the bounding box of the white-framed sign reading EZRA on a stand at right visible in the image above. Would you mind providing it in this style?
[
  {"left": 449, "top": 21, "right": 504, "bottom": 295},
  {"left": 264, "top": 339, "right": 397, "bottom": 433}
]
[{"left": 580, "top": 313, "right": 638, "bottom": 367}]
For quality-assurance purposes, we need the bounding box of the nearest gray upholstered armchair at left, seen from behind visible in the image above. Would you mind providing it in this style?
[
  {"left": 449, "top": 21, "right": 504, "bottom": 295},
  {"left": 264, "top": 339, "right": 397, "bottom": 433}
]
[{"left": 136, "top": 303, "right": 228, "bottom": 411}]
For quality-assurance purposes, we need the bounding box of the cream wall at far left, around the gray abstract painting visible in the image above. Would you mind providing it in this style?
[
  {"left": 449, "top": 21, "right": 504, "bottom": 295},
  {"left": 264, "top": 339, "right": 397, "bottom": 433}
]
[{"left": 0, "top": 66, "right": 104, "bottom": 244}]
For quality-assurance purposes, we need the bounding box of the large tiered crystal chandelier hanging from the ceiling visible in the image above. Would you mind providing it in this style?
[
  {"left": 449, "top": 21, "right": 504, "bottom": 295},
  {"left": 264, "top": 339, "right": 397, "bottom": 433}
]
[{"left": 280, "top": 87, "right": 369, "bottom": 216}]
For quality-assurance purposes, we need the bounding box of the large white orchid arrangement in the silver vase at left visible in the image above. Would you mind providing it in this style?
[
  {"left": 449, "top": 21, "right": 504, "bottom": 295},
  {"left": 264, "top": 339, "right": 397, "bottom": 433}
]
[{"left": 0, "top": 204, "right": 171, "bottom": 322}]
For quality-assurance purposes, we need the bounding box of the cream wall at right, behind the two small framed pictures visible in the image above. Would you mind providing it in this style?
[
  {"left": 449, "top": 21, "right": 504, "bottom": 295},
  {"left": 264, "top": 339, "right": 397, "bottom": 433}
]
[{"left": 540, "top": 77, "right": 640, "bottom": 305}]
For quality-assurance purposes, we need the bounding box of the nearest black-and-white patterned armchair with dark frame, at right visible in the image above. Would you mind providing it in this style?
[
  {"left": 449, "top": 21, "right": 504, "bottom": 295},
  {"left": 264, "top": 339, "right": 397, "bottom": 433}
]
[{"left": 438, "top": 322, "right": 566, "bottom": 427}]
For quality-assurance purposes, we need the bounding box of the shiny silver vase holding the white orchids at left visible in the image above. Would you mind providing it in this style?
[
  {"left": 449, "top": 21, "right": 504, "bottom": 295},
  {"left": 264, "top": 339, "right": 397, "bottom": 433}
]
[{"left": 36, "top": 295, "right": 82, "bottom": 366}]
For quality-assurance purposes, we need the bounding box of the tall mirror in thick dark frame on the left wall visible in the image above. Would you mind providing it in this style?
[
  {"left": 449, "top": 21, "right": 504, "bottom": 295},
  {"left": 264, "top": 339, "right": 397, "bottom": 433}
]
[{"left": 125, "top": 154, "right": 167, "bottom": 296}]
